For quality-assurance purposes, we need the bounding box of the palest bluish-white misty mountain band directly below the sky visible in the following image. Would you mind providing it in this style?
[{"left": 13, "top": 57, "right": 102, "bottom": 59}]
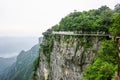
[{"left": 0, "top": 36, "right": 38, "bottom": 57}]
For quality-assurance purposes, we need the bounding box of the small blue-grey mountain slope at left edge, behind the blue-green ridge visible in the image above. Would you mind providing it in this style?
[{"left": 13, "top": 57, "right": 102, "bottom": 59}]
[{"left": 0, "top": 57, "right": 16, "bottom": 75}]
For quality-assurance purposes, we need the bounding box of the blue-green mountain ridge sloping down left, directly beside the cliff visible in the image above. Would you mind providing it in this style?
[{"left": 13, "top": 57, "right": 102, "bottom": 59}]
[{"left": 0, "top": 44, "right": 40, "bottom": 80}]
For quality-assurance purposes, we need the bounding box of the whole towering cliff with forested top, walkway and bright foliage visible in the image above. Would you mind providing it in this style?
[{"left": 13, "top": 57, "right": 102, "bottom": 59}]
[{"left": 34, "top": 6, "right": 119, "bottom": 80}]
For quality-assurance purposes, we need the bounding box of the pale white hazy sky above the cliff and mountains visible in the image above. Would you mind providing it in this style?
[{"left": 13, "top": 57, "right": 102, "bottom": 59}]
[{"left": 0, "top": 0, "right": 120, "bottom": 37}]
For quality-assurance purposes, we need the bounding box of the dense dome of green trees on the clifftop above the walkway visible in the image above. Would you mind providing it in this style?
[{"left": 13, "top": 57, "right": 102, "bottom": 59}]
[{"left": 52, "top": 6, "right": 113, "bottom": 32}]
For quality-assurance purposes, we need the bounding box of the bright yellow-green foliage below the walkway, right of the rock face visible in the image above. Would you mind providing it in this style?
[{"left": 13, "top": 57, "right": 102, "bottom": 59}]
[{"left": 83, "top": 40, "right": 117, "bottom": 80}]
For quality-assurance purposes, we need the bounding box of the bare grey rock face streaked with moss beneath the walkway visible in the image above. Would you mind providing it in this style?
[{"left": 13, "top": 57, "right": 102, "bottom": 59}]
[{"left": 35, "top": 35, "right": 100, "bottom": 80}]
